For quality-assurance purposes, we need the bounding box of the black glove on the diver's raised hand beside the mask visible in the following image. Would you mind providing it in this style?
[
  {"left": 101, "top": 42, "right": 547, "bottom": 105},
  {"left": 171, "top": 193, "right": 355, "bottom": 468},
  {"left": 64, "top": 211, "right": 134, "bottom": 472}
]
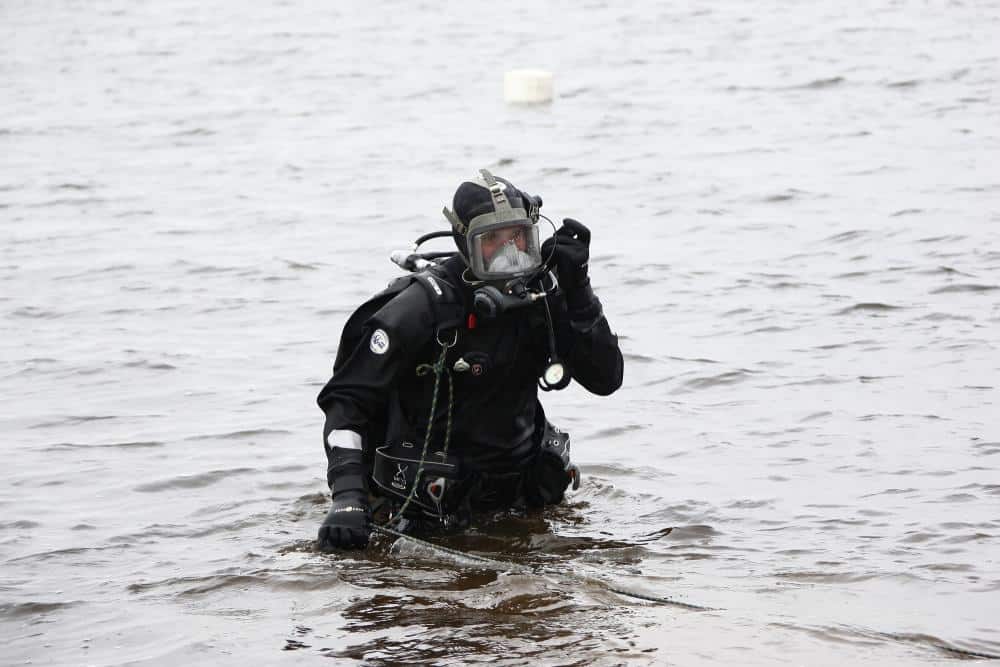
[{"left": 542, "top": 218, "right": 601, "bottom": 319}]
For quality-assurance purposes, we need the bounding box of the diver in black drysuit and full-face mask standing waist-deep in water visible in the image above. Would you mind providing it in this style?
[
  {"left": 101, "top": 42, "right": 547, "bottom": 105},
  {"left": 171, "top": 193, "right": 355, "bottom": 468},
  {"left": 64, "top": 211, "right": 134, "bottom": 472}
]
[{"left": 317, "top": 170, "right": 623, "bottom": 550}]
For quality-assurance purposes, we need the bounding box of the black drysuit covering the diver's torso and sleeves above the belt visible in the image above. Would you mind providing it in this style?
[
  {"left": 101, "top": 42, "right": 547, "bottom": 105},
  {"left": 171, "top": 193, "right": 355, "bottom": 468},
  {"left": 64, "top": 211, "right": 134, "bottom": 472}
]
[{"left": 317, "top": 255, "right": 623, "bottom": 512}]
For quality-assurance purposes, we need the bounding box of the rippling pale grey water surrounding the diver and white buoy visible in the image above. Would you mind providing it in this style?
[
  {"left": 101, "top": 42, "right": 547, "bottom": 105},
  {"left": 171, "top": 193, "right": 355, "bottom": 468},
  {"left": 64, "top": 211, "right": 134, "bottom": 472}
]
[{"left": 0, "top": 0, "right": 1000, "bottom": 665}]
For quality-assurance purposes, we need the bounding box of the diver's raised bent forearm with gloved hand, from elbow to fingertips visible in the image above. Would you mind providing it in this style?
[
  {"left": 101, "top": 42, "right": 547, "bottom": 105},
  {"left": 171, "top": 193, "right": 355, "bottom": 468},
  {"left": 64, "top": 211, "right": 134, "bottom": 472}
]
[{"left": 541, "top": 218, "right": 624, "bottom": 396}]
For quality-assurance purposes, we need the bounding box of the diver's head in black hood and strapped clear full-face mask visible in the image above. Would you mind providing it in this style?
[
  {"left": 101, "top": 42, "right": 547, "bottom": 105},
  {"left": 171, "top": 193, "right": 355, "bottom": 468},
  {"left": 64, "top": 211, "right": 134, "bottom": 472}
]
[{"left": 444, "top": 169, "right": 542, "bottom": 281}]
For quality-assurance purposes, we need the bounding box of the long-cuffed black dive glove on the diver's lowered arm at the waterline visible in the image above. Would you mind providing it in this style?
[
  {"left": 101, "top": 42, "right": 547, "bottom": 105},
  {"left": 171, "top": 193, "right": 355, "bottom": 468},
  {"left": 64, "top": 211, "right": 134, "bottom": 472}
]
[{"left": 317, "top": 447, "right": 372, "bottom": 551}]
